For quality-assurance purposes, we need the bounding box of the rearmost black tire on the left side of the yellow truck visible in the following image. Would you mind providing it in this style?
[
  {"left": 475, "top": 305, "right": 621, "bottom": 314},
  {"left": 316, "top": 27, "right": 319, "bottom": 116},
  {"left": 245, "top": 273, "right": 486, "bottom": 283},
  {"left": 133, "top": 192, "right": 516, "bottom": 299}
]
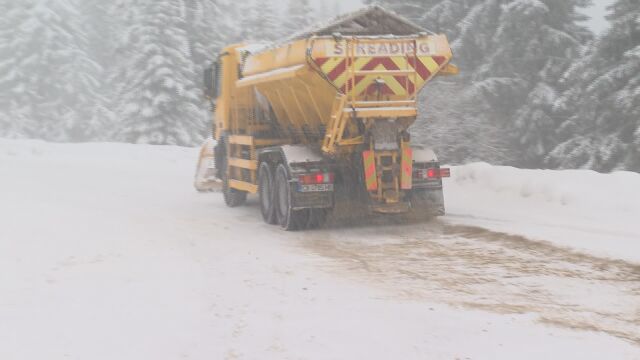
[{"left": 275, "top": 164, "right": 310, "bottom": 231}]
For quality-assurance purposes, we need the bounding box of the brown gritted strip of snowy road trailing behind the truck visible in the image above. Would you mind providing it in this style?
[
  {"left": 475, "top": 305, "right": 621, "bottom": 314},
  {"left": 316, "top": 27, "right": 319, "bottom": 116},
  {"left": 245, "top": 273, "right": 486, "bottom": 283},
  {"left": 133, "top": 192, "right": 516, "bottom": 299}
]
[{"left": 308, "top": 221, "right": 640, "bottom": 345}]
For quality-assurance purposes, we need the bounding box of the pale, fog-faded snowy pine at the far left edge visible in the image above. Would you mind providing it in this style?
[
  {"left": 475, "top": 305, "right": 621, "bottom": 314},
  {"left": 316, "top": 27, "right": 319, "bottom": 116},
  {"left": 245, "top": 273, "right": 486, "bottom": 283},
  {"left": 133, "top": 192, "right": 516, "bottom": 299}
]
[{"left": 0, "top": 0, "right": 101, "bottom": 141}]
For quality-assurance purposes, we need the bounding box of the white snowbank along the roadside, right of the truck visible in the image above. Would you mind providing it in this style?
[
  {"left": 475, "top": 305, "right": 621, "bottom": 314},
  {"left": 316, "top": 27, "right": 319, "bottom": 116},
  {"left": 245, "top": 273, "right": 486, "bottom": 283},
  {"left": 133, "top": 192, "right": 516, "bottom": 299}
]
[{"left": 442, "top": 163, "right": 640, "bottom": 263}]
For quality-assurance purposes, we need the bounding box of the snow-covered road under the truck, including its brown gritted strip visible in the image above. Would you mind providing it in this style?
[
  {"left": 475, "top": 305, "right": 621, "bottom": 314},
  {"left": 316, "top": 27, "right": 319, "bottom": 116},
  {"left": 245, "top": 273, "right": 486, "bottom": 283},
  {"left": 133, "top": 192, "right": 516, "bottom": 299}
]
[{"left": 0, "top": 140, "right": 640, "bottom": 360}]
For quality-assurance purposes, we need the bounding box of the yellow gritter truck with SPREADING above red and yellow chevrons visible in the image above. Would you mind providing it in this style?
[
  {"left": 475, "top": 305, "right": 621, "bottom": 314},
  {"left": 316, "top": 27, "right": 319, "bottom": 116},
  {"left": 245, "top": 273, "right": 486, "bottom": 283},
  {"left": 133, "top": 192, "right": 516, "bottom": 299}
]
[{"left": 200, "top": 6, "right": 457, "bottom": 230}]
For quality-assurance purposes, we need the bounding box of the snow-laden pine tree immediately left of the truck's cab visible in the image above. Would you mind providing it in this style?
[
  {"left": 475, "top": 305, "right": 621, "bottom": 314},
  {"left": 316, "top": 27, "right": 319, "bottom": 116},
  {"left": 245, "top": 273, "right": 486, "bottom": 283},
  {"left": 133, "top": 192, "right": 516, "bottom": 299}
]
[{"left": 115, "top": 0, "right": 208, "bottom": 145}]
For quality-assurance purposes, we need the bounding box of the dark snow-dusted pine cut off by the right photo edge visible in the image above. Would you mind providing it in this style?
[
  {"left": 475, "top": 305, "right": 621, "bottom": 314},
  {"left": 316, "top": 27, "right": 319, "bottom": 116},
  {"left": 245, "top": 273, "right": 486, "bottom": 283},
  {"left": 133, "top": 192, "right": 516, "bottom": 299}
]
[{"left": 547, "top": 0, "right": 640, "bottom": 172}]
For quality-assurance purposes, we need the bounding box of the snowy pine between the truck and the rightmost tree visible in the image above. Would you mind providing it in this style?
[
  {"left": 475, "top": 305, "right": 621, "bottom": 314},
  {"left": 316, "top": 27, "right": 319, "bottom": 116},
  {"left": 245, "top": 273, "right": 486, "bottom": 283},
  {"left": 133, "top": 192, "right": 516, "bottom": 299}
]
[{"left": 457, "top": 0, "right": 591, "bottom": 167}]
